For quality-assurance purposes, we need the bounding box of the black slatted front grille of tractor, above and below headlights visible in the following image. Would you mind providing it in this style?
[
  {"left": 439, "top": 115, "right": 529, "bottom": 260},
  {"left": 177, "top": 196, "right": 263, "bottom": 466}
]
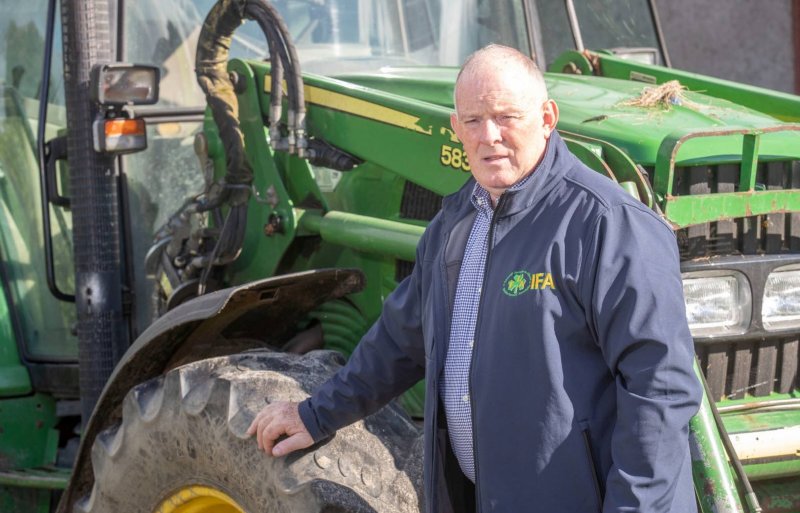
[{"left": 675, "top": 162, "right": 800, "bottom": 401}]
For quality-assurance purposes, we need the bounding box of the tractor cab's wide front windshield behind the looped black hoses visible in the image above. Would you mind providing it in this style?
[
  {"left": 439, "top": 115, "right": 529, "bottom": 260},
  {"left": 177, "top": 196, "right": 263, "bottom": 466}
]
[{"left": 125, "top": 0, "right": 530, "bottom": 107}]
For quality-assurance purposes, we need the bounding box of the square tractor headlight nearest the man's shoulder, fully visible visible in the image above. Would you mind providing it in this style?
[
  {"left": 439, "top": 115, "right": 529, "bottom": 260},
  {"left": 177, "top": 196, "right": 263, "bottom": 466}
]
[{"left": 683, "top": 271, "right": 752, "bottom": 337}]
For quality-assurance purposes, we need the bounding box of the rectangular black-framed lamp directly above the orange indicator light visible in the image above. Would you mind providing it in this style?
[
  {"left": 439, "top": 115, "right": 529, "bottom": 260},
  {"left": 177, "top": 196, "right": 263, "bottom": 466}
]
[{"left": 90, "top": 63, "right": 161, "bottom": 107}]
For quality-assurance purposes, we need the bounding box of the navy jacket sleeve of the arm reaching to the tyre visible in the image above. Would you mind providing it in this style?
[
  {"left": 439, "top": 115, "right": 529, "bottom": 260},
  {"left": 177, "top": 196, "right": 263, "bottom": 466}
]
[{"left": 299, "top": 227, "right": 428, "bottom": 442}]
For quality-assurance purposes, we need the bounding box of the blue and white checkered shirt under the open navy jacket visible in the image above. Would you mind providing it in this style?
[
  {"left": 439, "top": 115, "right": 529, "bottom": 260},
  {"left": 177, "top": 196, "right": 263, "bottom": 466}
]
[{"left": 442, "top": 173, "right": 532, "bottom": 483}]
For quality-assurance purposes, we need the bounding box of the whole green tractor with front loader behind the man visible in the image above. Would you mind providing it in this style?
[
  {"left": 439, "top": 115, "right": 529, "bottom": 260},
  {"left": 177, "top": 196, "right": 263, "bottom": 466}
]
[{"left": 0, "top": 0, "right": 800, "bottom": 513}]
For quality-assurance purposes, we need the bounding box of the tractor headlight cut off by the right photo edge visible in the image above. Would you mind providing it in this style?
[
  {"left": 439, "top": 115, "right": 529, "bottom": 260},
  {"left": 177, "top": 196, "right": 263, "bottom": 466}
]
[{"left": 761, "top": 266, "right": 800, "bottom": 331}]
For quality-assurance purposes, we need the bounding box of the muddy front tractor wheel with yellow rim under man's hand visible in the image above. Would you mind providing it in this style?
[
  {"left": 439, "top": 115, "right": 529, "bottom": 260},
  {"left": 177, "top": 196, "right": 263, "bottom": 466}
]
[{"left": 74, "top": 351, "right": 422, "bottom": 513}]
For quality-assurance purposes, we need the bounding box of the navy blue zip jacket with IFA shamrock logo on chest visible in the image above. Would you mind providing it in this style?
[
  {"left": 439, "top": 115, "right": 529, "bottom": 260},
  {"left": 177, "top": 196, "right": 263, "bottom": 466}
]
[{"left": 300, "top": 133, "right": 702, "bottom": 513}]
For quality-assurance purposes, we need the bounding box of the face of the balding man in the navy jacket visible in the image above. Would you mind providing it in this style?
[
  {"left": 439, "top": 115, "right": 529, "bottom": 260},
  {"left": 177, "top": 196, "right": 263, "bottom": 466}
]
[{"left": 450, "top": 64, "right": 558, "bottom": 198}]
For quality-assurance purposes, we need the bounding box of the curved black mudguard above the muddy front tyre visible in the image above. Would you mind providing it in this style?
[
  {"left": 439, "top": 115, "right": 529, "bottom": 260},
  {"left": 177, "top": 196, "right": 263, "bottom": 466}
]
[{"left": 56, "top": 269, "right": 365, "bottom": 513}]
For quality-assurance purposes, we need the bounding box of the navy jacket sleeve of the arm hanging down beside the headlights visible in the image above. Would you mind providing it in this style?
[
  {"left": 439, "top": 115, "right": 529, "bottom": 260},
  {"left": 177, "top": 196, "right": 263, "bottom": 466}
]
[{"left": 582, "top": 203, "right": 702, "bottom": 513}]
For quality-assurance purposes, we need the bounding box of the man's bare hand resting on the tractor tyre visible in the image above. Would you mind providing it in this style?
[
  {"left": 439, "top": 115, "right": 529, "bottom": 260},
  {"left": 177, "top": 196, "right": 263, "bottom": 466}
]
[{"left": 247, "top": 402, "right": 314, "bottom": 456}]
